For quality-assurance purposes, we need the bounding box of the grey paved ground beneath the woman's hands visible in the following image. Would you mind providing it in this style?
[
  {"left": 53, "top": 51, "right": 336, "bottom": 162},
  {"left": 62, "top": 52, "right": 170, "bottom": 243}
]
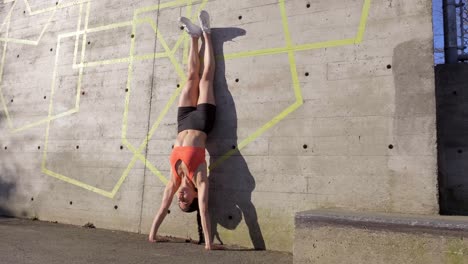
[{"left": 0, "top": 218, "right": 292, "bottom": 264}]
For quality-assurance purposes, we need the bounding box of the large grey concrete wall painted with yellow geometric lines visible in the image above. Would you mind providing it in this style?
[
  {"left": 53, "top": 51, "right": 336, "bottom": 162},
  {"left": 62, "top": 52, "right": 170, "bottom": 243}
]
[{"left": 0, "top": 0, "right": 438, "bottom": 251}]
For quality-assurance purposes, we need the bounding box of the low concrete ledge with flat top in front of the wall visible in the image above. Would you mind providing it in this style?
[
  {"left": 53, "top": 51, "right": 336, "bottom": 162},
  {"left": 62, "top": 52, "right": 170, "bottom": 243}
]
[{"left": 293, "top": 211, "right": 468, "bottom": 264}]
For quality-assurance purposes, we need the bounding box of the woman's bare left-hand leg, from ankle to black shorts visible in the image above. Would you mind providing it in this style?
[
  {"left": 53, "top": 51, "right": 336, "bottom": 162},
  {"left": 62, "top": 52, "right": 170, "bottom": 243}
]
[{"left": 179, "top": 36, "right": 200, "bottom": 107}]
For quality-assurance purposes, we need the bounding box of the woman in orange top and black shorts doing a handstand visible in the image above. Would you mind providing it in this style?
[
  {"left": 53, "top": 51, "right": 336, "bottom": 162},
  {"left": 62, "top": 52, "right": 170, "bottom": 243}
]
[{"left": 148, "top": 11, "right": 221, "bottom": 250}]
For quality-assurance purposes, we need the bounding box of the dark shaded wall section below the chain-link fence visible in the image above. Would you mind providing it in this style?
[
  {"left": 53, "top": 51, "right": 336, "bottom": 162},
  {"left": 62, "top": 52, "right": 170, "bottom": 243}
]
[{"left": 436, "top": 64, "right": 468, "bottom": 215}]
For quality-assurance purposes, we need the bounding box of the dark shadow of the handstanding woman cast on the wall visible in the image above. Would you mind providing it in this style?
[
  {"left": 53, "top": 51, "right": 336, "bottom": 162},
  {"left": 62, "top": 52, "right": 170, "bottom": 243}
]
[{"left": 201, "top": 28, "right": 265, "bottom": 250}]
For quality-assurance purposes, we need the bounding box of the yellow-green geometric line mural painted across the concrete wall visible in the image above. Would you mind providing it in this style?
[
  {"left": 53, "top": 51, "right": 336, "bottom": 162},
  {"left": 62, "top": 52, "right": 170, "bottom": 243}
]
[{"left": 4, "top": 0, "right": 371, "bottom": 198}]
